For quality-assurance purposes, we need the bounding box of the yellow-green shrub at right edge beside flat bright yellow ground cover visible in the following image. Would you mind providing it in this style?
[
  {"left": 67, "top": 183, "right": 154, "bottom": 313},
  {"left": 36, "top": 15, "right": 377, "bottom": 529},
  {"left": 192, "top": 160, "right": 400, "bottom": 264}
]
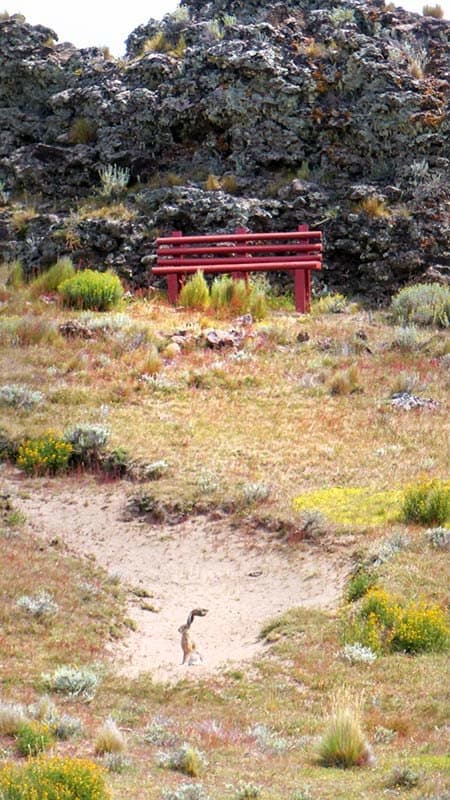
[{"left": 402, "top": 480, "right": 450, "bottom": 525}]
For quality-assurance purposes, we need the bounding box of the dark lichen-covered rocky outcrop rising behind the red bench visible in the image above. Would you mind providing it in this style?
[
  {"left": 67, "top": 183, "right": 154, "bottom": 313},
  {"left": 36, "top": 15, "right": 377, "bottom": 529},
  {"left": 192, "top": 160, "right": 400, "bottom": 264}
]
[{"left": 0, "top": 0, "right": 450, "bottom": 298}]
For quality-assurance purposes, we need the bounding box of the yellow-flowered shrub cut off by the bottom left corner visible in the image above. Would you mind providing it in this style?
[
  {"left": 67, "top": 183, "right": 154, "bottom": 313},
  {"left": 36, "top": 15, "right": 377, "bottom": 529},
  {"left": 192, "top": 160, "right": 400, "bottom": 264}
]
[{"left": 0, "top": 756, "right": 110, "bottom": 800}]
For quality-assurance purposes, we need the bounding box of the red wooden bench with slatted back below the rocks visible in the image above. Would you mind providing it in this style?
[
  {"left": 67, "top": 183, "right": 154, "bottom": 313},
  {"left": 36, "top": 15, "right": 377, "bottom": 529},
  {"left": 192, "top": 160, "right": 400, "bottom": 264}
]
[{"left": 152, "top": 225, "right": 322, "bottom": 313}]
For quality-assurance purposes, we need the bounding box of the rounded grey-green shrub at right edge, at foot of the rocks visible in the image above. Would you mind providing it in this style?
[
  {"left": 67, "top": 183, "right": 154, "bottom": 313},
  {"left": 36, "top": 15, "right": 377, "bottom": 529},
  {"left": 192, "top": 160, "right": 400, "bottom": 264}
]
[{"left": 391, "top": 283, "right": 450, "bottom": 328}]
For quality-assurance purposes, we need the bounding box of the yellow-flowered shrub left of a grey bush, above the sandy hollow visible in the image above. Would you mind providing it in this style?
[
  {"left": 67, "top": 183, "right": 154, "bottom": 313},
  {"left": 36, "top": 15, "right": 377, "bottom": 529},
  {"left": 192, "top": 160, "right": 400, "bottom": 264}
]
[{"left": 16, "top": 431, "right": 72, "bottom": 475}]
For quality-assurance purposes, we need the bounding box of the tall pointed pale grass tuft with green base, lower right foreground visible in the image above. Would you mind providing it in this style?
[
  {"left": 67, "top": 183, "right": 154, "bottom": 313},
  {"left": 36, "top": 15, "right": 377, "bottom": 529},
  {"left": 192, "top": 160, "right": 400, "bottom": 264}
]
[{"left": 317, "top": 688, "right": 372, "bottom": 769}]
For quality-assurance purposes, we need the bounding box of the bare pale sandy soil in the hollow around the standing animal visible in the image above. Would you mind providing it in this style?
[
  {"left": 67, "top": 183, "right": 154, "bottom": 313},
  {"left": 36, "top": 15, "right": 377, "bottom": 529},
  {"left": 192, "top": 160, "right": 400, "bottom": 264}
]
[{"left": 1, "top": 470, "right": 348, "bottom": 681}]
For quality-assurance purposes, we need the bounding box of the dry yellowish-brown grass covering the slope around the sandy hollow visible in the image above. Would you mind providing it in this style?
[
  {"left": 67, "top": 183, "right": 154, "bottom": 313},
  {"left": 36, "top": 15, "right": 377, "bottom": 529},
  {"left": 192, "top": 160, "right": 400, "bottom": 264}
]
[{"left": 0, "top": 295, "right": 449, "bottom": 800}]
